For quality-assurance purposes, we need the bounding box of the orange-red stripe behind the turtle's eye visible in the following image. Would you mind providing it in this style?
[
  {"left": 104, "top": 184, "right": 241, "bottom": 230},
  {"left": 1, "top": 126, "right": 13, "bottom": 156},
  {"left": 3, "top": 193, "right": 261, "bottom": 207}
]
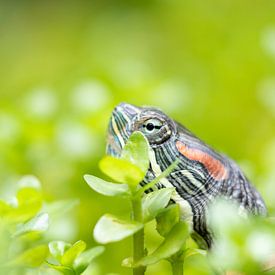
[{"left": 176, "top": 141, "right": 228, "bottom": 181}]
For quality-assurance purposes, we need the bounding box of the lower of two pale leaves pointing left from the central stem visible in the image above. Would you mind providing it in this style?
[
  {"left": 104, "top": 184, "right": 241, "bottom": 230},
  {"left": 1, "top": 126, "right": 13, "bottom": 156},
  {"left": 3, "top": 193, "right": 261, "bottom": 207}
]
[{"left": 94, "top": 214, "right": 143, "bottom": 244}]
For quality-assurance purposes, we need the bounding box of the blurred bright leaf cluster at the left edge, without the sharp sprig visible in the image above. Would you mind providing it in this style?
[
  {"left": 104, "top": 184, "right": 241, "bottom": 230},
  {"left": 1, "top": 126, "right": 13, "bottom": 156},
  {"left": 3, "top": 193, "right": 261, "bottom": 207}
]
[{"left": 0, "top": 176, "right": 49, "bottom": 272}]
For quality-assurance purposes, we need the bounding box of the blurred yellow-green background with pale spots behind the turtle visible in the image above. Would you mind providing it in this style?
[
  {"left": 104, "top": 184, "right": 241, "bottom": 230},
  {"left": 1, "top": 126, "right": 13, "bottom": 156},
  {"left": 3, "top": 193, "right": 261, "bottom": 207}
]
[{"left": 0, "top": 0, "right": 275, "bottom": 274}]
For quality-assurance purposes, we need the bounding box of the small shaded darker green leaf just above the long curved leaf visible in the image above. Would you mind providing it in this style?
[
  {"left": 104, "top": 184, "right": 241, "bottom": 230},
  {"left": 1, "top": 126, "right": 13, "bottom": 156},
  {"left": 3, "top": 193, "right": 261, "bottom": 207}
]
[{"left": 156, "top": 204, "right": 180, "bottom": 237}]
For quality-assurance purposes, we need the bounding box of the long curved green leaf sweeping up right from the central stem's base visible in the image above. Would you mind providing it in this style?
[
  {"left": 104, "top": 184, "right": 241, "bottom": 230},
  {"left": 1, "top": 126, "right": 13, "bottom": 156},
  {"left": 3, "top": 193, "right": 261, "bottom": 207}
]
[{"left": 134, "top": 222, "right": 189, "bottom": 266}]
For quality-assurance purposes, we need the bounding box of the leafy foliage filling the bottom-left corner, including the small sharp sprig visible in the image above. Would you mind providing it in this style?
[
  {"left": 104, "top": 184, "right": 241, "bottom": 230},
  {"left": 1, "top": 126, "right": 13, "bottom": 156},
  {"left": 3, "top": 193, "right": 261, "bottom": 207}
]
[{"left": 0, "top": 176, "right": 103, "bottom": 274}]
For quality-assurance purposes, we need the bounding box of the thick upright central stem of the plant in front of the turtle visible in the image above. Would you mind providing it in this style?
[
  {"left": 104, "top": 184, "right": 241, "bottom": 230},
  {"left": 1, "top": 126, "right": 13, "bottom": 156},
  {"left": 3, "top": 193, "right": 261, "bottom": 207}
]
[{"left": 132, "top": 197, "right": 145, "bottom": 275}]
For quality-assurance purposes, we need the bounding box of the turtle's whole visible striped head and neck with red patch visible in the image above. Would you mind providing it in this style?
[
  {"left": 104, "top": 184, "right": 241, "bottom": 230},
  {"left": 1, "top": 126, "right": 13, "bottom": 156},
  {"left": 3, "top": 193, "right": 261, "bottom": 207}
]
[{"left": 107, "top": 103, "right": 266, "bottom": 248}]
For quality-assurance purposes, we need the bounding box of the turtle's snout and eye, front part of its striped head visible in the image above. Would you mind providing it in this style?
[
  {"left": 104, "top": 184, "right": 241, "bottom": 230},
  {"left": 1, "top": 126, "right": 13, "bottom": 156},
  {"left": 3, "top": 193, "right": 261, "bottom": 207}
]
[{"left": 107, "top": 103, "right": 176, "bottom": 156}]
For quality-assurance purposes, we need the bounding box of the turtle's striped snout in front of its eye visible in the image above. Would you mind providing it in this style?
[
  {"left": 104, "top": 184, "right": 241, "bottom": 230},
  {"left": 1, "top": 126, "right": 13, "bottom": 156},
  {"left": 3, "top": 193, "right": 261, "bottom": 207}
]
[{"left": 106, "top": 103, "right": 141, "bottom": 157}]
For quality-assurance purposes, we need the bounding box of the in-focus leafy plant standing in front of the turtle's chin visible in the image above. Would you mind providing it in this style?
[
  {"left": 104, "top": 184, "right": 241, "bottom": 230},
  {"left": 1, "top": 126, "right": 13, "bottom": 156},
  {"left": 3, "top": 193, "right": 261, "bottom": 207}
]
[{"left": 84, "top": 132, "right": 205, "bottom": 275}]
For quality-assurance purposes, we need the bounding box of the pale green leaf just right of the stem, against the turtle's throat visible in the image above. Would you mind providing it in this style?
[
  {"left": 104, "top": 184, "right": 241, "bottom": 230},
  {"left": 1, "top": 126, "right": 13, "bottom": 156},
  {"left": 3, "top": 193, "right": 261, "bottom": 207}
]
[{"left": 142, "top": 188, "right": 175, "bottom": 222}]
